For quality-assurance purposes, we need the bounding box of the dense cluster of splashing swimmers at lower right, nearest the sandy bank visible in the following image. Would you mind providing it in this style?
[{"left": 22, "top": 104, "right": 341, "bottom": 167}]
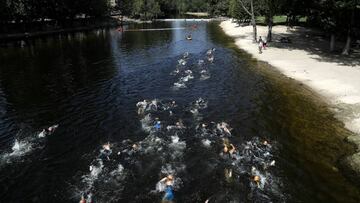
[{"left": 196, "top": 119, "right": 277, "bottom": 202}]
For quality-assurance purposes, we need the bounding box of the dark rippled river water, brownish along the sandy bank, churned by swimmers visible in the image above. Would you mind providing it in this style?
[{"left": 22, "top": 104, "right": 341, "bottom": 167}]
[{"left": 0, "top": 21, "right": 360, "bottom": 202}]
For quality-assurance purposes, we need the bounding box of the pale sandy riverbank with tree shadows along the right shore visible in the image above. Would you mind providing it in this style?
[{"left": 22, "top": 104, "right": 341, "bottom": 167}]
[{"left": 220, "top": 20, "right": 360, "bottom": 176}]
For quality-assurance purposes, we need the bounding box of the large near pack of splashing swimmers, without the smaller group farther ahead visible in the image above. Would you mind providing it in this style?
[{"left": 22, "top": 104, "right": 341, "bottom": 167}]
[{"left": 74, "top": 98, "right": 275, "bottom": 203}]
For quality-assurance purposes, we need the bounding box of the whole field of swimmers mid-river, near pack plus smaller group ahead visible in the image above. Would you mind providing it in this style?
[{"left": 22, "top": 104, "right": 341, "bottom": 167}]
[{"left": 76, "top": 27, "right": 275, "bottom": 203}]
